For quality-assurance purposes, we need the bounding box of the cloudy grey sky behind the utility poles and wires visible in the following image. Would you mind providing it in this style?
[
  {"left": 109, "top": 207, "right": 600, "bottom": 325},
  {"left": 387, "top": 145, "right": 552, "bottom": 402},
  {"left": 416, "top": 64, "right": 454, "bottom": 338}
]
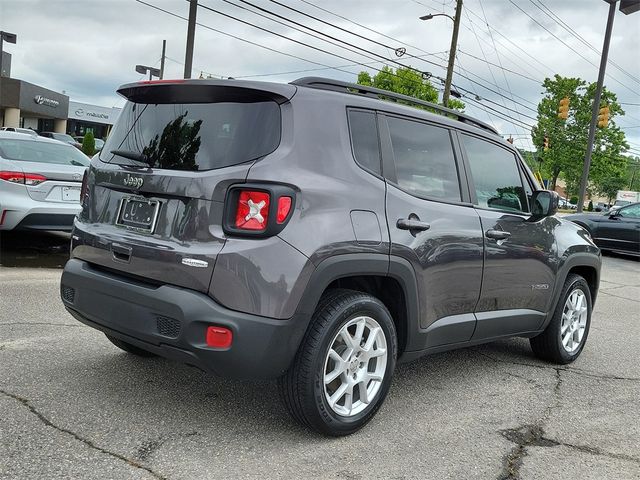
[{"left": 0, "top": 0, "right": 640, "bottom": 155}]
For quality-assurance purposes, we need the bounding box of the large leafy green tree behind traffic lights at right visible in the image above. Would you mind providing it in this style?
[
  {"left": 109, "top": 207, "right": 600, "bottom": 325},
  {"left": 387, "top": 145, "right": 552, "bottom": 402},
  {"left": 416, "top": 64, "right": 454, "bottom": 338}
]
[{"left": 531, "top": 75, "right": 629, "bottom": 194}]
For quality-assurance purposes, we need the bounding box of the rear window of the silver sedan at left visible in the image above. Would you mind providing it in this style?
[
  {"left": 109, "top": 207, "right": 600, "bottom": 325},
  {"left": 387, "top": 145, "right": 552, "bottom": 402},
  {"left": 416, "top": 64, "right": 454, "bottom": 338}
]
[{"left": 0, "top": 138, "right": 91, "bottom": 167}]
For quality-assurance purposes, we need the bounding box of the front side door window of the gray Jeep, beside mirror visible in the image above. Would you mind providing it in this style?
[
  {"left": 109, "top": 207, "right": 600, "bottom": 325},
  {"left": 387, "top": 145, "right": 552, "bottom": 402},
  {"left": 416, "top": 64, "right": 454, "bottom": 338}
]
[{"left": 461, "top": 135, "right": 529, "bottom": 212}]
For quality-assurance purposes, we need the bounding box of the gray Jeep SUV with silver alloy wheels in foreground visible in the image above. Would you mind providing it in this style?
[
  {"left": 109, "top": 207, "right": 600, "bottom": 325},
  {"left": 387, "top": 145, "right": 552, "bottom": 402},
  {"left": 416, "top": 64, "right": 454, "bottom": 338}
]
[{"left": 61, "top": 78, "right": 600, "bottom": 435}]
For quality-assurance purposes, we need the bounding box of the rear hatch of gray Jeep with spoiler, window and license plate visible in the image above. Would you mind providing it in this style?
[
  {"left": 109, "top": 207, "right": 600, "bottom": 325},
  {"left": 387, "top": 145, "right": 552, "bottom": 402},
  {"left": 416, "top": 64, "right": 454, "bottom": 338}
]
[{"left": 73, "top": 80, "right": 295, "bottom": 292}]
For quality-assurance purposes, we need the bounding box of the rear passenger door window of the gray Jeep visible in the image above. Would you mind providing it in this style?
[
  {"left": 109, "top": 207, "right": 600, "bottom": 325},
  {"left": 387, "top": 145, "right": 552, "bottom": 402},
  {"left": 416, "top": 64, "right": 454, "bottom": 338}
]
[{"left": 387, "top": 117, "right": 460, "bottom": 201}]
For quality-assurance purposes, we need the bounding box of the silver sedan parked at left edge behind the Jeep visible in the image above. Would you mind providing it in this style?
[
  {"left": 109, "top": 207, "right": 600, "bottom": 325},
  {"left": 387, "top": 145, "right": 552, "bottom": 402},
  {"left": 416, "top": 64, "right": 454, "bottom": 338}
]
[{"left": 0, "top": 131, "right": 90, "bottom": 231}]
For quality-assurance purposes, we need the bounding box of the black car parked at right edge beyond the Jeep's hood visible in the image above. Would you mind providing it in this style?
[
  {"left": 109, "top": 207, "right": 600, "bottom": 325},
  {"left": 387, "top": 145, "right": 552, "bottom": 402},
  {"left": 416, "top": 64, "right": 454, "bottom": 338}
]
[{"left": 564, "top": 203, "right": 640, "bottom": 255}]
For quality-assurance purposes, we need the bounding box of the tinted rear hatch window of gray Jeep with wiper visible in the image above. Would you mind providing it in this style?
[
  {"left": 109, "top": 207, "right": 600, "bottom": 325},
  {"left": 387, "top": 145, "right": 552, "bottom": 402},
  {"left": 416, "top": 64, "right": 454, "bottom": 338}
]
[{"left": 100, "top": 101, "right": 280, "bottom": 170}]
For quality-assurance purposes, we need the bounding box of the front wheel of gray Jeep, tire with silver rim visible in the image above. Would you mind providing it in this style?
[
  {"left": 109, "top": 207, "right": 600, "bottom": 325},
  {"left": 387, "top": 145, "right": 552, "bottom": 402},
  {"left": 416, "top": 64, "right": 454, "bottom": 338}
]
[{"left": 529, "top": 274, "right": 592, "bottom": 365}]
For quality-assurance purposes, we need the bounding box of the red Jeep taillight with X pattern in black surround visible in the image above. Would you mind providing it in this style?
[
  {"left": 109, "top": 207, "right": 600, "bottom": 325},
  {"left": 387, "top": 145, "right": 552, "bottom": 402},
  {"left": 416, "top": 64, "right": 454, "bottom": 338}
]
[{"left": 222, "top": 183, "right": 295, "bottom": 237}]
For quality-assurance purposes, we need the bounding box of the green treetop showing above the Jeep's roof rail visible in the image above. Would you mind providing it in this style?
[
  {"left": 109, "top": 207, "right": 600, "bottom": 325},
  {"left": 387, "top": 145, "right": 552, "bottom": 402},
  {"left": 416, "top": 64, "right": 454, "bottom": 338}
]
[{"left": 358, "top": 66, "right": 464, "bottom": 110}]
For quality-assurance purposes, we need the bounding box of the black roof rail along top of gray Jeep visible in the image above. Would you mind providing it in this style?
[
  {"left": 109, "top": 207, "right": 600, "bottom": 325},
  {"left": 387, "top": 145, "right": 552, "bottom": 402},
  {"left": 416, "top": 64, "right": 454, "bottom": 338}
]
[{"left": 291, "top": 77, "right": 498, "bottom": 135}]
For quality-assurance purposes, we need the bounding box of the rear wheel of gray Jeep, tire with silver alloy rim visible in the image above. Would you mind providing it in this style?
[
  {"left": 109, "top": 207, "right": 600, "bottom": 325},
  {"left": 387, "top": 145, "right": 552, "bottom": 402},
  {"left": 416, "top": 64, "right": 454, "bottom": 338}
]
[{"left": 278, "top": 289, "right": 398, "bottom": 437}]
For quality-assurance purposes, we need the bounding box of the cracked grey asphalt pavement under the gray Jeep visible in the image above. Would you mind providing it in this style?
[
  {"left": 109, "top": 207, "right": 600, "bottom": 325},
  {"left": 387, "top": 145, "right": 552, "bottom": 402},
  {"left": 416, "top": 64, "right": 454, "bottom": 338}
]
[{"left": 0, "top": 232, "right": 640, "bottom": 480}]
